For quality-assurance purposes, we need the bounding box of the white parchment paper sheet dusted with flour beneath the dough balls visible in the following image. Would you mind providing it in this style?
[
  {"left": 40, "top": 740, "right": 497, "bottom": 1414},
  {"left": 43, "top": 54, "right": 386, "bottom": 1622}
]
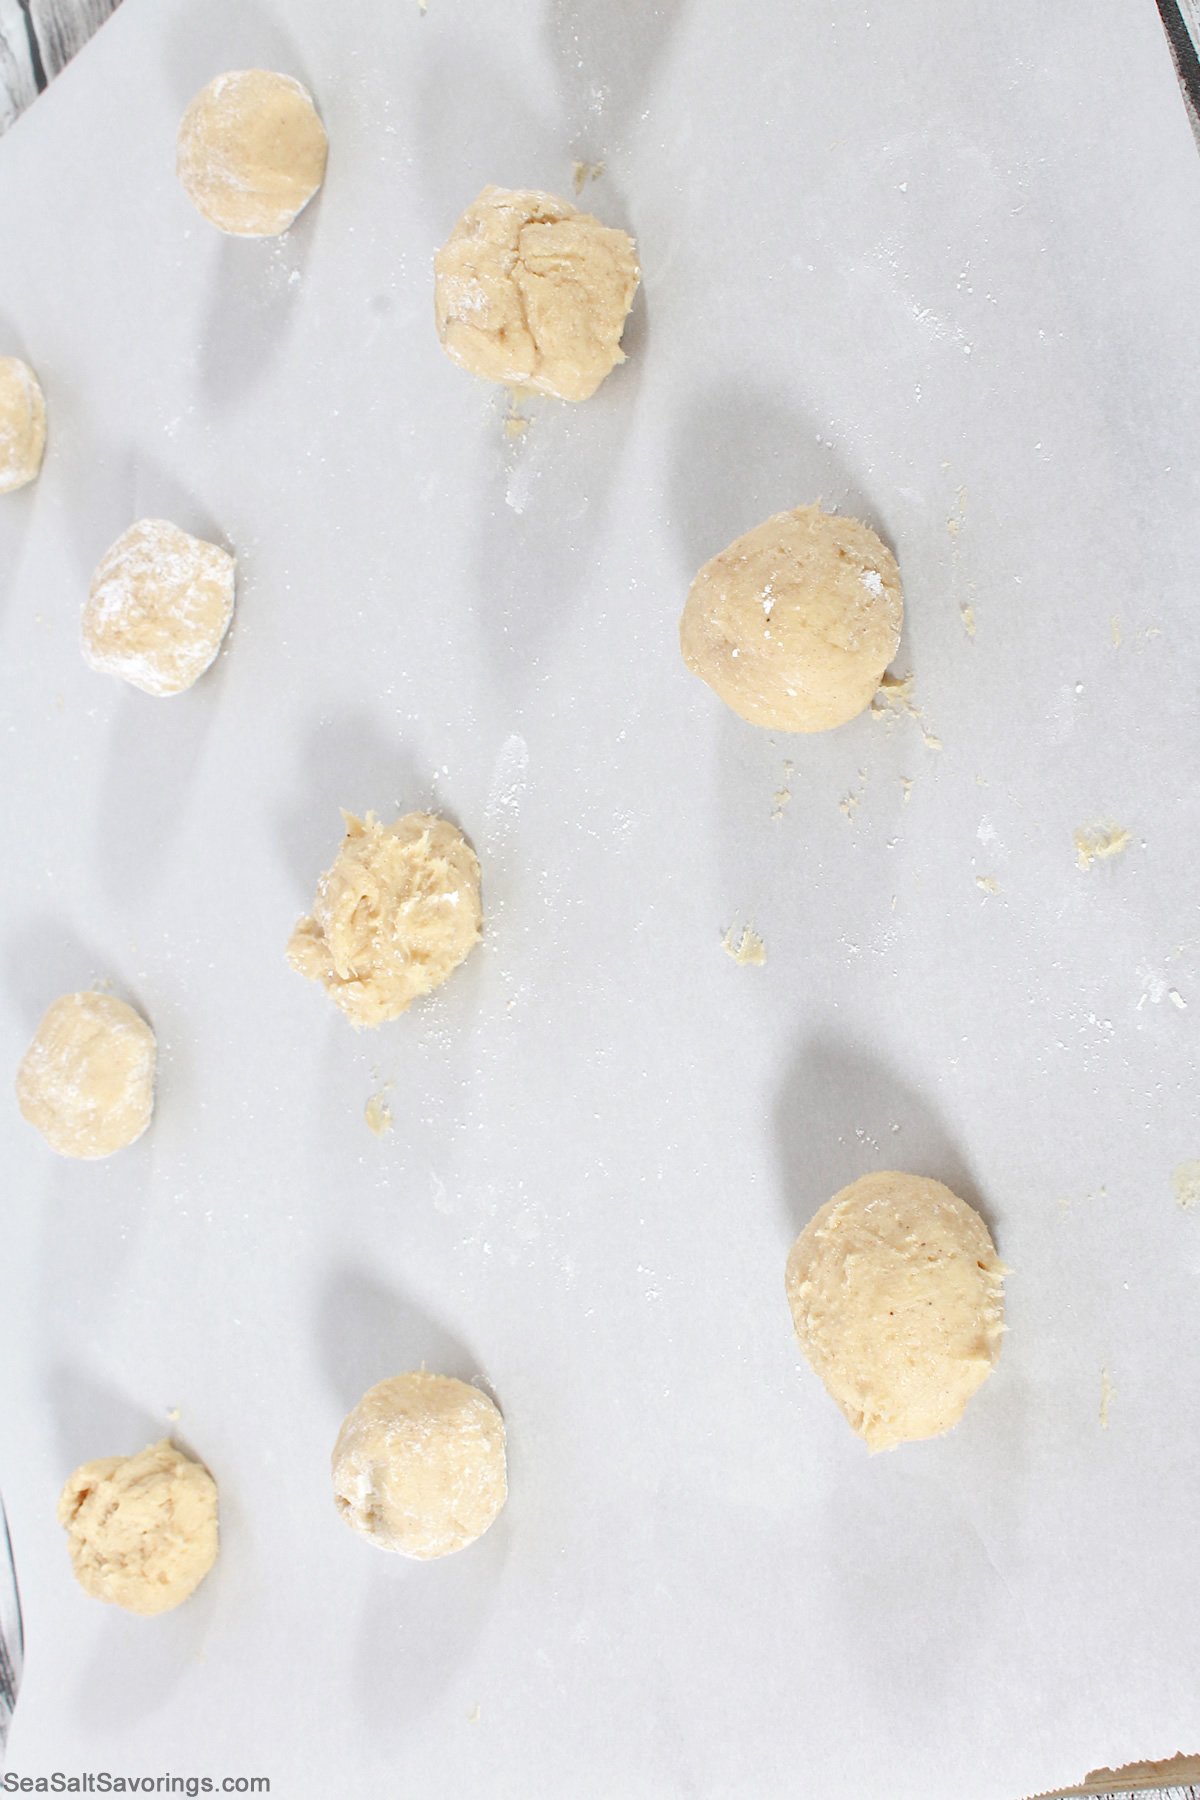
[{"left": 0, "top": 0, "right": 1200, "bottom": 1800}]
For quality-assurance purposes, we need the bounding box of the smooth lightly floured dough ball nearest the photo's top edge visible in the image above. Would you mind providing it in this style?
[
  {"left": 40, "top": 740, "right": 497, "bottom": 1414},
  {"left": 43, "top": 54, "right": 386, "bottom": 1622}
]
[{"left": 175, "top": 68, "right": 329, "bottom": 238}]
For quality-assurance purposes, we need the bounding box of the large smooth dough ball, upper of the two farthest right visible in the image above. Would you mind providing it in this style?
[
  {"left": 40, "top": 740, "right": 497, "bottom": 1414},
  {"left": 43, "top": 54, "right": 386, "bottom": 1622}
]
[{"left": 680, "top": 506, "right": 905, "bottom": 731}]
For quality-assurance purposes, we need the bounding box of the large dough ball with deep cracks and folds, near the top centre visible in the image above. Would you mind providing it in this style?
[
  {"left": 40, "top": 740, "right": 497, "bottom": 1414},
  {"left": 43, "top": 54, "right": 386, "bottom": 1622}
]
[{"left": 434, "top": 187, "right": 640, "bottom": 400}]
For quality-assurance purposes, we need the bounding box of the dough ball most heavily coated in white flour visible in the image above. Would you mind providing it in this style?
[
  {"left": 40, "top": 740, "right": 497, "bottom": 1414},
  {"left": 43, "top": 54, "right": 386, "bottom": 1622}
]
[{"left": 83, "top": 518, "right": 236, "bottom": 695}]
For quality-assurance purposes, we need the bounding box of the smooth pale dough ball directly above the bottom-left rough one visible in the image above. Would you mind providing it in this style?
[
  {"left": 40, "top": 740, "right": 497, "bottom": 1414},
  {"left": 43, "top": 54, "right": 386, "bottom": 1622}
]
[{"left": 16, "top": 994, "right": 155, "bottom": 1157}]
